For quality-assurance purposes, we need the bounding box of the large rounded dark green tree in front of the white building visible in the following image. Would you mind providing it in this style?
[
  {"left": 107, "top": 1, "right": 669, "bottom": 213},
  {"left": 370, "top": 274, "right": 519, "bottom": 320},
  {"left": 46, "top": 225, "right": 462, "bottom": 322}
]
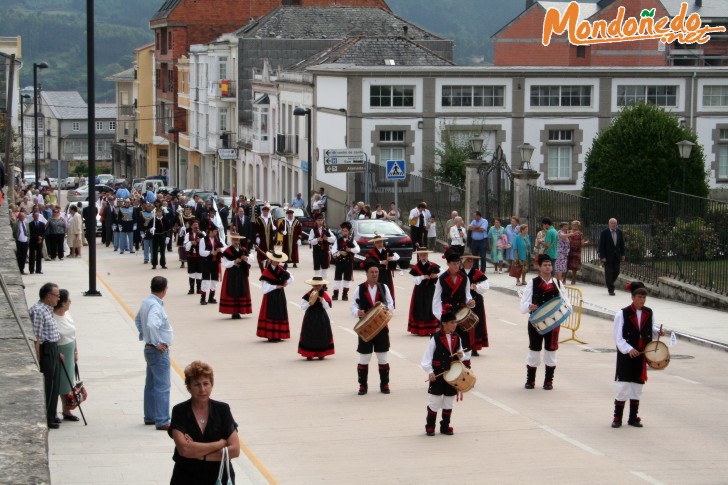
[{"left": 583, "top": 103, "right": 708, "bottom": 201}]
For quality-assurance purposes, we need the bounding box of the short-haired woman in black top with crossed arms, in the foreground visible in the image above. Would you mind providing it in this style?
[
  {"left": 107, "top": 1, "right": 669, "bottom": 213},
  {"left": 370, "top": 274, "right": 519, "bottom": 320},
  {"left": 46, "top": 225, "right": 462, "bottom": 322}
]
[{"left": 168, "top": 360, "right": 240, "bottom": 485}]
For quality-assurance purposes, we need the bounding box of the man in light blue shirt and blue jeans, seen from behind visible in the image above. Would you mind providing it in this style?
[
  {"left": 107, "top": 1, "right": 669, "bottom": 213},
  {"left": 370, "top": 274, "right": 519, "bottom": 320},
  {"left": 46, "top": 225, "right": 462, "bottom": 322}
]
[{"left": 134, "top": 276, "right": 174, "bottom": 431}]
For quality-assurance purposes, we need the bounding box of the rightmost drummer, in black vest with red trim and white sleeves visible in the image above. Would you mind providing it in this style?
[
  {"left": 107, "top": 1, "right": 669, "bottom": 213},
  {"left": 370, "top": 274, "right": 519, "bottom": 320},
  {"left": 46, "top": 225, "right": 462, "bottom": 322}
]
[{"left": 612, "top": 281, "right": 665, "bottom": 428}]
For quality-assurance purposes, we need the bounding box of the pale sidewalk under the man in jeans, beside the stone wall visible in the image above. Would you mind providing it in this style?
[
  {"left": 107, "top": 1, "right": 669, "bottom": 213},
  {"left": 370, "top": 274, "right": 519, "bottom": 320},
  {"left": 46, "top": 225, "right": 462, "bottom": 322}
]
[{"left": 23, "top": 258, "right": 267, "bottom": 485}]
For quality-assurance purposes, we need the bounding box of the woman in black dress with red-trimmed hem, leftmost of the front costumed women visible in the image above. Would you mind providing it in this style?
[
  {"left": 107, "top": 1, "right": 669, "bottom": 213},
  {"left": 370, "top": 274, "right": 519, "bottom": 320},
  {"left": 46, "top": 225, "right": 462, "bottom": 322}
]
[{"left": 220, "top": 234, "right": 255, "bottom": 320}]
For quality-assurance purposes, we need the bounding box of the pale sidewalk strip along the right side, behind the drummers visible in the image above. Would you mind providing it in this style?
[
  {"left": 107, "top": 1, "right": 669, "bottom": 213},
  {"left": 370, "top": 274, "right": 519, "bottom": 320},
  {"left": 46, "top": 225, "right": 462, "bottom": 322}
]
[{"left": 485, "top": 263, "right": 728, "bottom": 351}]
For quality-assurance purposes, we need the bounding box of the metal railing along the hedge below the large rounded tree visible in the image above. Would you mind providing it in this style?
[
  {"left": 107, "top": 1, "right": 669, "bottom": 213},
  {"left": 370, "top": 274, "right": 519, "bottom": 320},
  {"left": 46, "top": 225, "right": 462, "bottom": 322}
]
[{"left": 529, "top": 187, "right": 728, "bottom": 295}]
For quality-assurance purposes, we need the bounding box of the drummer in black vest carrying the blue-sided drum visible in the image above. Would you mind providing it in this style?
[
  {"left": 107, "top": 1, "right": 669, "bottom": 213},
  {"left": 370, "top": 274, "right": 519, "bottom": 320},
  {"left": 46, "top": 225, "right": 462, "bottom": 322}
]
[{"left": 521, "top": 254, "right": 561, "bottom": 391}]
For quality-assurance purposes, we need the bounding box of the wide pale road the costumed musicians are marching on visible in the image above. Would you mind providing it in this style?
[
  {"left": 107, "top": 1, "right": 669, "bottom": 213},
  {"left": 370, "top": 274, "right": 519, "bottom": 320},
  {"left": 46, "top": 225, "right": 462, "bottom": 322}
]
[{"left": 89, "top": 239, "right": 728, "bottom": 484}]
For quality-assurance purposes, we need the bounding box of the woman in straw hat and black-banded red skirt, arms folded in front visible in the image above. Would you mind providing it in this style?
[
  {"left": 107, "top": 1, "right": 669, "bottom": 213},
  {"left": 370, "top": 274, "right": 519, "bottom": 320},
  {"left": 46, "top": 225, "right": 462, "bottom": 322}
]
[{"left": 256, "top": 247, "right": 293, "bottom": 342}]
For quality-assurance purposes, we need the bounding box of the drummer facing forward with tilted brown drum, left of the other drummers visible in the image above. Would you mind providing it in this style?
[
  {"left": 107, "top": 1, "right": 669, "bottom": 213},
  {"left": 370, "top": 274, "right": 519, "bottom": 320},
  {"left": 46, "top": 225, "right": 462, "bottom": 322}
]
[{"left": 351, "top": 258, "right": 394, "bottom": 396}]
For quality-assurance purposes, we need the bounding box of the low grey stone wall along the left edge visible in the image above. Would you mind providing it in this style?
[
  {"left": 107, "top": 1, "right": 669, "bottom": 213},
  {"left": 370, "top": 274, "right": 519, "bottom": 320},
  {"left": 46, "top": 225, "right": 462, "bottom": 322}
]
[{"left": 0, "top": 201, "right": 50, "bottom": 484}]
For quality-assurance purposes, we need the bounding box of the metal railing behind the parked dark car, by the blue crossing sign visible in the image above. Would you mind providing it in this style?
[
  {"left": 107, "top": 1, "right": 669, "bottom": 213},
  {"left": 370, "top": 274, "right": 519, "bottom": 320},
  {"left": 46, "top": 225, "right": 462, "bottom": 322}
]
[{"left": 354, "top": 164, "right": 465, "bottom": 239}]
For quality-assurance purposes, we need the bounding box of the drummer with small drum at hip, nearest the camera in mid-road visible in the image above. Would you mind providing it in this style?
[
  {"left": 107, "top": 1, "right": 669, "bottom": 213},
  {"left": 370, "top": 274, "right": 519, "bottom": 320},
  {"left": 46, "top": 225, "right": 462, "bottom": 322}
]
[{"left": 421, "top": 303, "right": 463, "bottom": 436}]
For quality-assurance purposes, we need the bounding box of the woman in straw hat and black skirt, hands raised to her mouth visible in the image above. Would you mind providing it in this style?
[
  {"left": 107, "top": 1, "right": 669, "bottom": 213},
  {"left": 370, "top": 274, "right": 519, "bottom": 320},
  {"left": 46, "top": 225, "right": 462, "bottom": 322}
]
[{"left": 298, "top": 276, "right": 334, "bottom": 360}]
